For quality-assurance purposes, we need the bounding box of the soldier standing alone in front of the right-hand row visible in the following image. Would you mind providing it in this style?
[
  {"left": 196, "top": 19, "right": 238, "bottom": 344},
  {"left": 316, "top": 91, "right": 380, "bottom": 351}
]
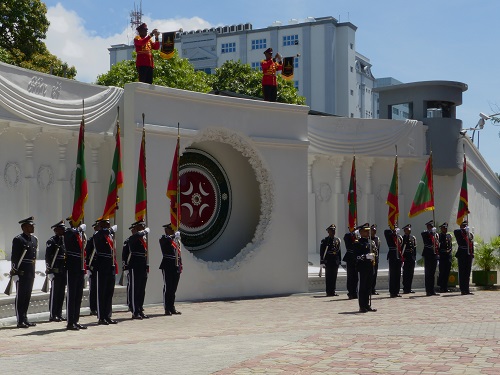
[{"left": 353, "top": 223, "right": 377, "bottom": 313}]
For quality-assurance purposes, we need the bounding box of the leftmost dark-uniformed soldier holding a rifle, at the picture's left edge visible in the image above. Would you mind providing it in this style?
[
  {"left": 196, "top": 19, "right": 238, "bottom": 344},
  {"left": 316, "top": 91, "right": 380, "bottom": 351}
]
[{"left": 10, "top": 216, "right": 38, "bottom": 328}]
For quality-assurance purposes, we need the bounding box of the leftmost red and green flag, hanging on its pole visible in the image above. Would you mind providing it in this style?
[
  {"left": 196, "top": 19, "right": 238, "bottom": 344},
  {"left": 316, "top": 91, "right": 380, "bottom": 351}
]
[{"left": 71, "top": 118, "right": 88, "bottom": 224}]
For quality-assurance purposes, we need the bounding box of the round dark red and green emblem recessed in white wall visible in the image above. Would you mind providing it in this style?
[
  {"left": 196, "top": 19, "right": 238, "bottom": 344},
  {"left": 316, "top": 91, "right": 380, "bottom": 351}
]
[{"left": 179, "top": 148, "right": 231, "bottom": 251}]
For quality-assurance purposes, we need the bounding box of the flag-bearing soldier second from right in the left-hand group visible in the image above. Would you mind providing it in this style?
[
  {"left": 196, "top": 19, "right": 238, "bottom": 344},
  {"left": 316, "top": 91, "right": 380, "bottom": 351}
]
[{"left": 123, "top": 220, "right": 149, "bottom": 319}]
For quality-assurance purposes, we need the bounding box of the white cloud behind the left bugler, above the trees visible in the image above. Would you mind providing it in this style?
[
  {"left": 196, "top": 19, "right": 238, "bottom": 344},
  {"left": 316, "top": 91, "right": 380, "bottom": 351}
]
[{"left": 45, "top": 3, "right": 211, "bottom": 82}]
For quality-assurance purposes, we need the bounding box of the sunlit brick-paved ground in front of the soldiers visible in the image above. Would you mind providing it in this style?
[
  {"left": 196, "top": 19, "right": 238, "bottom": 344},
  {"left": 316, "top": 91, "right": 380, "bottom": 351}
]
[{"left": 0, "top": 291, "right": 500, "bottom": 375}]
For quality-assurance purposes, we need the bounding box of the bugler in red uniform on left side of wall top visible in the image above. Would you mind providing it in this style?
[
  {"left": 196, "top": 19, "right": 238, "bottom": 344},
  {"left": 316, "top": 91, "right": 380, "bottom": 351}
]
[{"left": 134, "top": 23, "right": 160, "bottom": 84}]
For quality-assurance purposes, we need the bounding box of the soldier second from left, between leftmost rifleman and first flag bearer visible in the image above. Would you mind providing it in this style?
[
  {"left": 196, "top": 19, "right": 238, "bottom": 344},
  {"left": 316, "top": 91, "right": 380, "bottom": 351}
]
[{"left": 45, "top": 220, "right": 66, "bottom": 322}]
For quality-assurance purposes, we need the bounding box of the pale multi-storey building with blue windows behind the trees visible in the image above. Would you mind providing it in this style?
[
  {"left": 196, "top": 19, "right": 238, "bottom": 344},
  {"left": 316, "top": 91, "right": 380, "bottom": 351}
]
[{"left": 109, "top": 17, "right": 376, "bottom": 118}]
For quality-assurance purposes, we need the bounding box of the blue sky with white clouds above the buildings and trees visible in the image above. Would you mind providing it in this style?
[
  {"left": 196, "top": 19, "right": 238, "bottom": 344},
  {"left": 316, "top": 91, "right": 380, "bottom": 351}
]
[{"left": 44, "top": 0, "right": 500, "bottom": 173}]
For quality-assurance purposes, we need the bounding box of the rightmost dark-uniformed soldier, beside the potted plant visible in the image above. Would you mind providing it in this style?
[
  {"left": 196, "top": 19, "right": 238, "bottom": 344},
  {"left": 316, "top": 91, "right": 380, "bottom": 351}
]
[{"left": 453, "top": 220, "right": 474, "bottom": 295}]
